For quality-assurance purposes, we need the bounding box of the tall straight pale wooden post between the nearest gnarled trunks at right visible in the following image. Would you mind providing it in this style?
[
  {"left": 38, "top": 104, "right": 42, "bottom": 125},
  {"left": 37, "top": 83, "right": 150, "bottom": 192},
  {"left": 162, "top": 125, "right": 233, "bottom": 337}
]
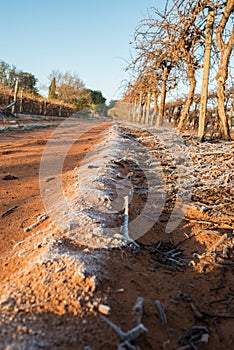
[{"left": 198, "top": 7, "right": 214, "bottom": 138}]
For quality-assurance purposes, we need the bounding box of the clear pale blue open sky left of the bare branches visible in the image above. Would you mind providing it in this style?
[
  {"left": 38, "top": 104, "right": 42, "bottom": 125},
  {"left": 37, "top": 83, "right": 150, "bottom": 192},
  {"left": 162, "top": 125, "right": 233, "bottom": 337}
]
[{"left": 0, "top": 0, "right": 165, "bottom": 100}]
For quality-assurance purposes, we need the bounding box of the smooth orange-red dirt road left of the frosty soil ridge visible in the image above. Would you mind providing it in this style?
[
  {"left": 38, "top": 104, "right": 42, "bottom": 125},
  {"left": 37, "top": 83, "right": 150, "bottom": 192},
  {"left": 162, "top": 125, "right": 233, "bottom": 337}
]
[{"left": 0, "top": 119, "right": 109, "bottom": 274}]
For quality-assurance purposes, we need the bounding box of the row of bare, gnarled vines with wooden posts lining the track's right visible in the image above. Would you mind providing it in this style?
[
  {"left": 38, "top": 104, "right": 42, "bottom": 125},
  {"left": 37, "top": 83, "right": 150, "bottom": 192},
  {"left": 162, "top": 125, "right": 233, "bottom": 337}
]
[{"left": 124, "top": 0, "right": 234, "bottom": 140}]
